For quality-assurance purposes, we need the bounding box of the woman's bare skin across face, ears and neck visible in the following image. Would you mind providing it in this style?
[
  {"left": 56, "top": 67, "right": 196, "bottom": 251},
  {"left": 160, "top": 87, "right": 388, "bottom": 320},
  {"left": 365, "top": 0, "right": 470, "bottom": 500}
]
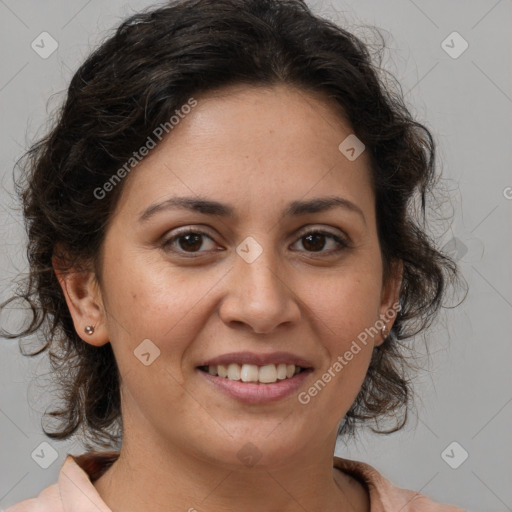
[{"left": 57, "top": 85, "right": 401, "bottom": 512}]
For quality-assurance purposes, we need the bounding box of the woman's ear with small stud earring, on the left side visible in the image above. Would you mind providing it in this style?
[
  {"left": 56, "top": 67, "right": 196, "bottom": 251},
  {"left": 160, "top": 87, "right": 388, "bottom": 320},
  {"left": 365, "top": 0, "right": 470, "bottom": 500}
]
[{"left": 52, "top": 256, "right": 109, "bottom": 347}]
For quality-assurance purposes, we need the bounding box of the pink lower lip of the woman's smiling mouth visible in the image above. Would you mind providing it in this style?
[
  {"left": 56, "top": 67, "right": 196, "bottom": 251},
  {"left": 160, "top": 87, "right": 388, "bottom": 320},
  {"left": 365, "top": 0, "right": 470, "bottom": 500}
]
[{"left": 196, "top": 369, "right": 312, "bottom": 404}]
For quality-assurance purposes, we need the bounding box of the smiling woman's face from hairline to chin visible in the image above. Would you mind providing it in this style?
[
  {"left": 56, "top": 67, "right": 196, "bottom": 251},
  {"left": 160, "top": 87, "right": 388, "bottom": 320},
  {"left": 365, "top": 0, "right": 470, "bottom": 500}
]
[{"left": 84, "top": 86, "right": 399, "bottom": 466}]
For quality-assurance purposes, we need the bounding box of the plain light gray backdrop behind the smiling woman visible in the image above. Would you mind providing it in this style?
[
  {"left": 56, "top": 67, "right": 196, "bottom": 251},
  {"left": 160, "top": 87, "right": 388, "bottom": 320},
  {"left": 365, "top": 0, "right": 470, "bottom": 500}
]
[{"left": 0, "top": 0, "right": 512, "bottom": 512}]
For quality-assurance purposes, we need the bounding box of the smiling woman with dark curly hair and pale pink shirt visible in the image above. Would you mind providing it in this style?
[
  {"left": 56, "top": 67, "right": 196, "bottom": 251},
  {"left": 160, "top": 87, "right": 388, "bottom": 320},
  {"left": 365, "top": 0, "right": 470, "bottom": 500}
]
[{"left": 3, "top": 0, "right": 468, "bottom": 512}]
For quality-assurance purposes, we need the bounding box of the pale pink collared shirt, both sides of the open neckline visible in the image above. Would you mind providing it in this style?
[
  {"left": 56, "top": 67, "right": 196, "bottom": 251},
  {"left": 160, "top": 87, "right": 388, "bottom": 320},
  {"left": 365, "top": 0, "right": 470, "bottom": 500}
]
[{"left": 6, "top": 452, "right": 466, "bottom": 512}]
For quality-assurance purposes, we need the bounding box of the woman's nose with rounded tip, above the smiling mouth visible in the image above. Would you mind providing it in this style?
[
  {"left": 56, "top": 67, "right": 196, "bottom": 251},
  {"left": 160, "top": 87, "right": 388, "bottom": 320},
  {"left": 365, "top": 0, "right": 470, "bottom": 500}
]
[{"left": 219, "top": 242, "right": 301, "bottom": 334}]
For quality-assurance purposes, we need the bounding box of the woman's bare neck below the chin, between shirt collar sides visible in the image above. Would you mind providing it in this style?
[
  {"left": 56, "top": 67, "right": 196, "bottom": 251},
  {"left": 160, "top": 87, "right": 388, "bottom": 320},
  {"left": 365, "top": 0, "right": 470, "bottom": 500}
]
[{"left": 94, "top": 438, "right": 370, "bottom": 512}]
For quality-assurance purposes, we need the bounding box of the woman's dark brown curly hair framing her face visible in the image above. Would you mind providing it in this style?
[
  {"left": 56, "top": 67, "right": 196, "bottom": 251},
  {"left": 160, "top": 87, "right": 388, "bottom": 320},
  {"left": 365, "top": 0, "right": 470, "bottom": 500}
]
[{"left": 2, "top": 0, "right": 459, "bottom": 447}]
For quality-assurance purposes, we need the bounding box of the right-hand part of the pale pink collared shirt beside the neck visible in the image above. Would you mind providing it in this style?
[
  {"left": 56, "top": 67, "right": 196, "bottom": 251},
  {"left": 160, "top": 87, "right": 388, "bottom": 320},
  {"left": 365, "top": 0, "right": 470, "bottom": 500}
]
[{"left": 334, "top": 457, "right": 466, "bottom": 512}]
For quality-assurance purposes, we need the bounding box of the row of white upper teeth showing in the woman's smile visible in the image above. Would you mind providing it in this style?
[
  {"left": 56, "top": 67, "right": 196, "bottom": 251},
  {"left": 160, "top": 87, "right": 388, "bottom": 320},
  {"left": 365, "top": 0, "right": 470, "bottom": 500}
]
[{"left": 202, "top": 363, "right": 300, "bottom": 384}]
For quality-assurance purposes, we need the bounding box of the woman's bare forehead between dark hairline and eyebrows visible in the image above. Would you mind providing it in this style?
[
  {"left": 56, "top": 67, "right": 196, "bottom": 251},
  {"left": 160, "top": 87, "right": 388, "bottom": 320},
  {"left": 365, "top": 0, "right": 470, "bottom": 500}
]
[{"left": 114, "top": 86, "right": 373, "bottom": 224}]
